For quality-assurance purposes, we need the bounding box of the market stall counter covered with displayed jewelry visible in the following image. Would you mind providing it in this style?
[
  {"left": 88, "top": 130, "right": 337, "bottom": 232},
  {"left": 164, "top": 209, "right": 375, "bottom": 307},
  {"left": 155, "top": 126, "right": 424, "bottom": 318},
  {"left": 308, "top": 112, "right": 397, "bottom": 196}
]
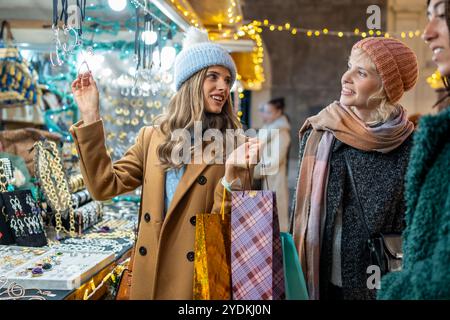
[{"left": 0, "top": 201, "right": 139, "bottom": 300}]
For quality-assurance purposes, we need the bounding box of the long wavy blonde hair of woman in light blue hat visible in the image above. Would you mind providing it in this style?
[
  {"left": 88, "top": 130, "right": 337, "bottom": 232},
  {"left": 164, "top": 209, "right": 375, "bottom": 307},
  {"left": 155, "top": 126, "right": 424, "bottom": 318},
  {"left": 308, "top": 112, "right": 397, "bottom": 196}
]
[{"left": 154, "top": 68, "right": 241, "bottom": 170}]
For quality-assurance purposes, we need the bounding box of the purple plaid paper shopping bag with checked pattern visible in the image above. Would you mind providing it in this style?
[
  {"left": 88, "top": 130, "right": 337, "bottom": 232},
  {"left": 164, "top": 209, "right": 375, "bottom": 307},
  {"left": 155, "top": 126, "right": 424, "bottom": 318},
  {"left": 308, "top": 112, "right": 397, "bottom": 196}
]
[{"left": 231, "top": 191, "right": 285, "bottom": 300}]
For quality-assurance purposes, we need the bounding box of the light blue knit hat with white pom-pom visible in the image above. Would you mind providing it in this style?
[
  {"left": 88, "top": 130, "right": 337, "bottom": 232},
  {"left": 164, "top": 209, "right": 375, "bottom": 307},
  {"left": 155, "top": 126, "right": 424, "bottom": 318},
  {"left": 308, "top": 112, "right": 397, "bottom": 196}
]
[{"left": 174, "top": 27, "right": 237, "bottom": 90}]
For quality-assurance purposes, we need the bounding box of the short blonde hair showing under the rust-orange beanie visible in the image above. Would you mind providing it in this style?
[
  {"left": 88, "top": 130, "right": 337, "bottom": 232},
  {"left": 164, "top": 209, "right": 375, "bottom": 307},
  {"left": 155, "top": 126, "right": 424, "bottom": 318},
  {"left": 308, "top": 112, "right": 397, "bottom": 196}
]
[{"left": 352, "top": 48, "right": 400, "bottom": 126}]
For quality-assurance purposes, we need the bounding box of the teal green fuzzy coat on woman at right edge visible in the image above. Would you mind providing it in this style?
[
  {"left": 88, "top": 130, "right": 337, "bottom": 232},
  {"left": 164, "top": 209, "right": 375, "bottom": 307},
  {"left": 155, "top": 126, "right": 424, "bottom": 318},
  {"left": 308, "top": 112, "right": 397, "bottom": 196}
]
[{"left": 378, "top": 107, "right": 450, "bottom": 299}]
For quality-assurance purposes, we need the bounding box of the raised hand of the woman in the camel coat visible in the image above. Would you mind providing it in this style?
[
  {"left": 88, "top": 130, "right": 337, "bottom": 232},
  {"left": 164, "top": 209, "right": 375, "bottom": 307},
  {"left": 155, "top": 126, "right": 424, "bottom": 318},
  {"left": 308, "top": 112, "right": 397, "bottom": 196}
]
[{"left": 72, "top": 72, "right": 100, "bottom": 125}]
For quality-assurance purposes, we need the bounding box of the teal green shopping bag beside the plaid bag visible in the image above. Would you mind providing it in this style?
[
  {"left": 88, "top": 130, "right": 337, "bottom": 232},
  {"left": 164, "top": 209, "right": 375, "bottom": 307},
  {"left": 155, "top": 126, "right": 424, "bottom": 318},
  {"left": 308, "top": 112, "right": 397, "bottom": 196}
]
[{"left": 280, "top": 232, "right": 308, "bottom": 300}]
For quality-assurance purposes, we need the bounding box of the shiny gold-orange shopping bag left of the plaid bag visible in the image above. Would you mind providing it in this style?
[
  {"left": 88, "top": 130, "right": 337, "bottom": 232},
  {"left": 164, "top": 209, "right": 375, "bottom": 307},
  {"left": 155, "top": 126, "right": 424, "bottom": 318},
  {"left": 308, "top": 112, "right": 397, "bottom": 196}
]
[{"left": 193, "top": 189, "right": 231, "bottom": 300}]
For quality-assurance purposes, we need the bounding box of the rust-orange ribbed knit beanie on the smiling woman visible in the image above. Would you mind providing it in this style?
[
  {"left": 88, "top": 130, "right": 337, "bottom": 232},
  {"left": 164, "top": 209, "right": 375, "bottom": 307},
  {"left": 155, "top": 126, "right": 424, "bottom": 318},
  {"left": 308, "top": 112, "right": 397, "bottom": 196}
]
[{"left": 353, "top": 37, "right": 419, "bottom": 103}]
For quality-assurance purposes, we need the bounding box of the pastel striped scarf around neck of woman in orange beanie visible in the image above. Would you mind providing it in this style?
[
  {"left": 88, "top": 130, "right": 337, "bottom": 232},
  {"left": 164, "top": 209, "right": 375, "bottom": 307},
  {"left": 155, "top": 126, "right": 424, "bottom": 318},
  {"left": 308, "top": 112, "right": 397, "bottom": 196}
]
[{"left": 293, "top": 102, "right": 414, "bottom": 300}]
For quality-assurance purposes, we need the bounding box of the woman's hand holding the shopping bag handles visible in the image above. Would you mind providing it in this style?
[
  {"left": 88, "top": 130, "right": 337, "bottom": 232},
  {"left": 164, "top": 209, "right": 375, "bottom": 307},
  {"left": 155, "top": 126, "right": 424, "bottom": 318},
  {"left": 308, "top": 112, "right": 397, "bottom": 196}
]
[{"left": 225, "top": 138, "right": 262, "bottom": 182}]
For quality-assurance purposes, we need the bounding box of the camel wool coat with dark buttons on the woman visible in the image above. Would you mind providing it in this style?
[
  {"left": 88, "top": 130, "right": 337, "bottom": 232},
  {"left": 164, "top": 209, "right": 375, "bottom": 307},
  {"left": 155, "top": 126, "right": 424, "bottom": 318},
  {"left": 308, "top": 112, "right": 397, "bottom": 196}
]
[{"left": 70, "top": 120, "right": 244, "bottom": 300}]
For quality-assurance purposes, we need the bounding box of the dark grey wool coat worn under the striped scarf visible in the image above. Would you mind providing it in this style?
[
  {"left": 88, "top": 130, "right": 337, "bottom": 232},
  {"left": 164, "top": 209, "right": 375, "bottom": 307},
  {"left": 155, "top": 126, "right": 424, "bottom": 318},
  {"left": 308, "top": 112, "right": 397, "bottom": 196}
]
[{"left": 293, "top": 129, "right": 412, "bottom": 300}]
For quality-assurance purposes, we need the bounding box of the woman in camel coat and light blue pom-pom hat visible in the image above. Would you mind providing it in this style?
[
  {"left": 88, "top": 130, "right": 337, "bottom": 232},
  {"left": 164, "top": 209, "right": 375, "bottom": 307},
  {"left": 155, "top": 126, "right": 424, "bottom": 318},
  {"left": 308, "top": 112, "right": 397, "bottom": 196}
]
[{"left": 71, "top": 31, "right": 259, "bottom": 299}]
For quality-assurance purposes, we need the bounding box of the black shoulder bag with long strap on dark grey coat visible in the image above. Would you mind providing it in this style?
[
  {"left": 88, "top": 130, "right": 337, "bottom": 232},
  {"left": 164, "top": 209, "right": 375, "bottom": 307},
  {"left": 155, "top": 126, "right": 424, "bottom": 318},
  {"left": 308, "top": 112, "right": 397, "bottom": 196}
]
[{"left": 344, "top": 155, "right": 403, "bottom": 275}]
